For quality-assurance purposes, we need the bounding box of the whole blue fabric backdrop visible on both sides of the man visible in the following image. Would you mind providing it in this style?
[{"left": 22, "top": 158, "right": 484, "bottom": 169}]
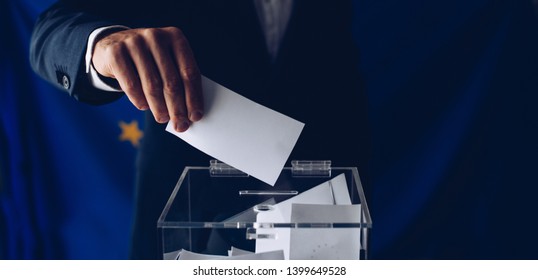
[{"left": 0, "top": 0, "right": 538, "bottom": 259}]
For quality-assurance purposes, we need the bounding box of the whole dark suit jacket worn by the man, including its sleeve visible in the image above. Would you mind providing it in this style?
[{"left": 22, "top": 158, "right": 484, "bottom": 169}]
[{"left": 30, "top": 0, "right": 370, "bottom": 259}]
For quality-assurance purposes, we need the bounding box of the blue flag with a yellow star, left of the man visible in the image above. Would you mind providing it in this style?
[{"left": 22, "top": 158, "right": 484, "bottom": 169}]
[{"left": 0, "top": 0, "right": 143, "bottom": 259}]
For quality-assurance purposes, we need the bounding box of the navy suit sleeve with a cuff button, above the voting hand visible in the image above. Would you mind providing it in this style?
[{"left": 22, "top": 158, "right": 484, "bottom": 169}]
[{"left": 30, "top": 1, "right": 123, "bottom": 105}]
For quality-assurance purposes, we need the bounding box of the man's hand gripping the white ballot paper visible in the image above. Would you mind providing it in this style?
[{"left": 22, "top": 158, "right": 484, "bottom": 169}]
[{"left": 92, "top": 27, "right": 203, "bottom": 132}]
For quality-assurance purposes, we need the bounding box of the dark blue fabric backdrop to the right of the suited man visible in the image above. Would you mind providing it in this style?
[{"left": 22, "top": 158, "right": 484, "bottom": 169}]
[{"left": 355, "top": 0, "right": 538, "bottom": 259}]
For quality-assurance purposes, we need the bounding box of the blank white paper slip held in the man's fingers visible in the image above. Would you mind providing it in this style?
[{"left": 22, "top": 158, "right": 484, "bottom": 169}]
[{"left": 166, "top": 76, "right": 304, "bottom": 186}]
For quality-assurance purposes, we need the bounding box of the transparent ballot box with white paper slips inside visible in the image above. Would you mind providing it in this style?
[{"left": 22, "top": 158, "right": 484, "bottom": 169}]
[{"left": 157, "top": 161, "right": 372, "bottom": 259}]
